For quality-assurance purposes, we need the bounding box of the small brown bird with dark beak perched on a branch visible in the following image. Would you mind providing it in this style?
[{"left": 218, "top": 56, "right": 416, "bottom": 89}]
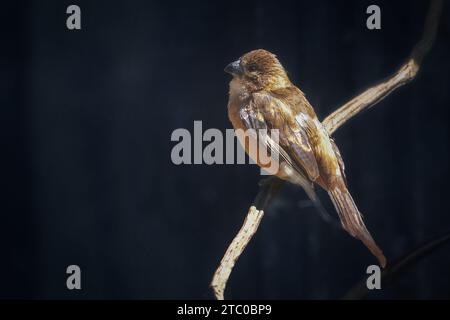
[{"left": 225, "top": 49, "right": 386, "bottom": 267}]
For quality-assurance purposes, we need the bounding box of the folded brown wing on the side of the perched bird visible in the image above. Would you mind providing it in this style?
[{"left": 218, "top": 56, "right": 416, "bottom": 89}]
[{"left": 240, "top": 92, "right": 319, "bottom": 181}]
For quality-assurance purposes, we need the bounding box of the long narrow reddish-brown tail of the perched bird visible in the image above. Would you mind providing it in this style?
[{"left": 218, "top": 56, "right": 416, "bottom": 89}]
[{"left": 328, "top": 188, "right": 386, "bottom": 268}]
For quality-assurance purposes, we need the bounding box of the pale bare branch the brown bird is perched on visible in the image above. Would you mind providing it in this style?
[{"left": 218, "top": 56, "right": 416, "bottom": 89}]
[{"left": 211, "top": 0, "right": 442, "bottom": 300}]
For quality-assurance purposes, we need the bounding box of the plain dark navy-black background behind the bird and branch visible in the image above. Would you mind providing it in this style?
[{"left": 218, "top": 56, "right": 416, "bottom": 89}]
[{"left": 0, "top": 0, "right": 450, "bottom": 299}]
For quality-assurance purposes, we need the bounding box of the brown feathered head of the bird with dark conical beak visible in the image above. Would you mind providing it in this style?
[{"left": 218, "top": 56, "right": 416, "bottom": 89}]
[{"left": 225, "top": 49, "right": 291, "bottom": 92}]
